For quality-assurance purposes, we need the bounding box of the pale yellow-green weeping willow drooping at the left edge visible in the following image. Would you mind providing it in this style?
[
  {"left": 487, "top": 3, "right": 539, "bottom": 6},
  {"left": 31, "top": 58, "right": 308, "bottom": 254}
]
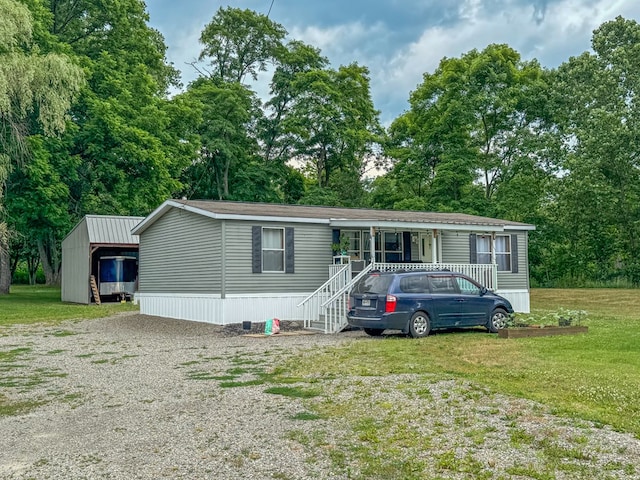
[{"left": 0, "top": 0, "right": 82, "bottom": 294}]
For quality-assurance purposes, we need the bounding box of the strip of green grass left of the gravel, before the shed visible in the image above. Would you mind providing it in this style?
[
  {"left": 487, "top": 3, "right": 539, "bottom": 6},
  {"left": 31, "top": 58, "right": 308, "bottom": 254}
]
[{"left": 0, "top": 285, "right": 138, "bottom": 326}]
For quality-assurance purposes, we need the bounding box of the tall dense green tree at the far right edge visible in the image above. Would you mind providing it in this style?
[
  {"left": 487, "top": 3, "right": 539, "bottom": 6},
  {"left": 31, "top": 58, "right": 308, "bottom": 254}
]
[{"left": 552, "top": 17, "right": 640, "bottom": 284}]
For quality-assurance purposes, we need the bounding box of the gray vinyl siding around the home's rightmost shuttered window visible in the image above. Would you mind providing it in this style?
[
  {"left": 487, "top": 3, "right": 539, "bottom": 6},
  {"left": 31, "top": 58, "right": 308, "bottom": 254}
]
[{"left": 441, "top": 231, "right": 529, "bottom": 290}]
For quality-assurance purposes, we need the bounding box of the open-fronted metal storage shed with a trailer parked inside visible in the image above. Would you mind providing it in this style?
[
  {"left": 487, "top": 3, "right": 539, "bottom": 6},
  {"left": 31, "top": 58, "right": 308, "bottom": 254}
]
[{"left": 62, "top": 215, "right": 144, "bottom": 304}]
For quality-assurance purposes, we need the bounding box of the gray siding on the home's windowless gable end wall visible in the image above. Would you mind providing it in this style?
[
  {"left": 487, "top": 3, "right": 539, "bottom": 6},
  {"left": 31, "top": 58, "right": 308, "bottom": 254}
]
[{"left": 138, "top": 208, "right": 222, "bottom": 294}]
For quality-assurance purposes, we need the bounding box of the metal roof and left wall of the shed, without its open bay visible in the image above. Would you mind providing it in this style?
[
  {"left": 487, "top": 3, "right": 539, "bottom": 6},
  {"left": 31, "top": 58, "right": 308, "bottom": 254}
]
[{"left": 61, "top": 215, "right": 144, "bottom": 304}]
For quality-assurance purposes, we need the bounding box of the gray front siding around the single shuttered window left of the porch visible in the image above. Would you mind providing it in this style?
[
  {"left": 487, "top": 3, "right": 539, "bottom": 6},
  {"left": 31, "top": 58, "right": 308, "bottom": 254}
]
[{"left": 225, "top": 220, "right": 332, "bottom": 295}]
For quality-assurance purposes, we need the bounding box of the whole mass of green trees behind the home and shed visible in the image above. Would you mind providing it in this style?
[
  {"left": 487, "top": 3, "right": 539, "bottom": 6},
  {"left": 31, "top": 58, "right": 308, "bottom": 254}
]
[{"left": 0, "top": 0, "right": 640, "bottom": 292}]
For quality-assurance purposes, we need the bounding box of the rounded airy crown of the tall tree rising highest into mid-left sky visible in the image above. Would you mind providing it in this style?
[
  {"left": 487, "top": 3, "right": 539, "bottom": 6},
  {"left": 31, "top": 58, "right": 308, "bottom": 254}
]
[{"left": 199, "top": 7, "right": 287, "bottom": 83}]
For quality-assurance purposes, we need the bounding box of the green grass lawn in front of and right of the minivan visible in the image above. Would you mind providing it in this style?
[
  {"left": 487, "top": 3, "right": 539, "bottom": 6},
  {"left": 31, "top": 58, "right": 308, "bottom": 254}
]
[{"left": 281, "top": 289, "right": 640, "bottom": 437}]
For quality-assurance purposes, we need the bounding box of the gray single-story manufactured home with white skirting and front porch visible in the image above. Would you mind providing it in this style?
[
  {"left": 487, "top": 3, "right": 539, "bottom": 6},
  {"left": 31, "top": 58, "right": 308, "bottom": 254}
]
[{"left": 132, "top": 200, "right": 534, "bottom": 332}]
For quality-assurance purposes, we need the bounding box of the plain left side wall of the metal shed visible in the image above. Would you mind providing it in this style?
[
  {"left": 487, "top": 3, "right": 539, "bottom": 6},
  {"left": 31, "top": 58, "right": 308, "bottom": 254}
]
[{"left": 61, "top": 220, "right": 91, "bottom": 304}]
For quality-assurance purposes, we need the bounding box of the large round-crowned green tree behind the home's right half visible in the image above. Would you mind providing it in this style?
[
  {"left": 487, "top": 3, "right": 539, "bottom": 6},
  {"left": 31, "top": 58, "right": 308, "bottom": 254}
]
[{"left": 386, "top": 45, "right": 551, "bottom": 216}]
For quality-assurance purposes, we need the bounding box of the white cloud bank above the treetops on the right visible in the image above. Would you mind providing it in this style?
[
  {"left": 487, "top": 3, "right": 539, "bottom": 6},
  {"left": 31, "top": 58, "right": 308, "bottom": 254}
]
[{"left": 372, "top": 0, "right": 640, "bottom": 123}]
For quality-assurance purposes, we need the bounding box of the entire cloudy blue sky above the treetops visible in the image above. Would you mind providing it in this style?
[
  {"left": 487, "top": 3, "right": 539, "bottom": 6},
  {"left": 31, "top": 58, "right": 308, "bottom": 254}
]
[{"left": 147, "top": 0, "right": 640, "bottom": 125}]
